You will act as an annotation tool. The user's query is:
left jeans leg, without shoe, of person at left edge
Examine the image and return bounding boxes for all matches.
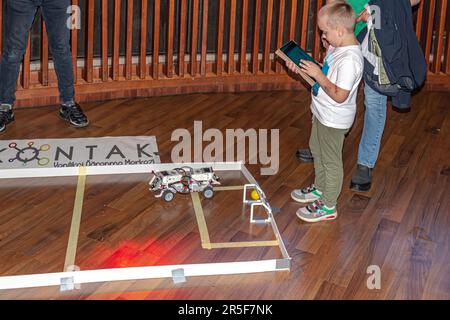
[0,0,37,106]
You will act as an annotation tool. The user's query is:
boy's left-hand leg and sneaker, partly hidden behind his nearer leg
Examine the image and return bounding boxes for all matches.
[291,117,325,203]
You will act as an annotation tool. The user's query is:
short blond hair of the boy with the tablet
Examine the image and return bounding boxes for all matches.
[319,0,356,33]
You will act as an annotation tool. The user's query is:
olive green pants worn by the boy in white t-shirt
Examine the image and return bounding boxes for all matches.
[309,116,349,208]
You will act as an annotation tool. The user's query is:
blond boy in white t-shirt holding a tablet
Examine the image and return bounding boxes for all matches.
[287,1,364,222]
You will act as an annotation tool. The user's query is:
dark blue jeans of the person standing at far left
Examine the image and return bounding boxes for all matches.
[0,0,74,105]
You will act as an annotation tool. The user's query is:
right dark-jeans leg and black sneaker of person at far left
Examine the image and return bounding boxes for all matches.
[42,0,89,127]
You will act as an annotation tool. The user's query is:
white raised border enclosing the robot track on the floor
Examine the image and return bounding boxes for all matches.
[0,162,291,291]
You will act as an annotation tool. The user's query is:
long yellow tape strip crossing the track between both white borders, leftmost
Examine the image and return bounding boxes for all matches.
[64,167,86,271]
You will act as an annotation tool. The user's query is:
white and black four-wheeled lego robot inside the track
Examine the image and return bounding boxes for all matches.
[149,167,220,202]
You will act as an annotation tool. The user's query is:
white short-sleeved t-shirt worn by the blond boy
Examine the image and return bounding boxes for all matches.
[311,45,364,129]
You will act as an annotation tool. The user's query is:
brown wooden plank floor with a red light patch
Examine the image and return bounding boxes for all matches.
[0,91,450,299]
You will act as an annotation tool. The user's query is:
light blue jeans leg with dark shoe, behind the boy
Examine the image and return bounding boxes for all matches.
[350,84,387,191]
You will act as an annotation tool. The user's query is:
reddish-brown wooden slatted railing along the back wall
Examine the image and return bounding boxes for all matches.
[0,0,450,107]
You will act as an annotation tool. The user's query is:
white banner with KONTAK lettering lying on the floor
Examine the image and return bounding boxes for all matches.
[0,136,161,170]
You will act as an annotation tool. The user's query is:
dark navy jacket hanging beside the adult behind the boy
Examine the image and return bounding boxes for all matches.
[358,0,427,109]
